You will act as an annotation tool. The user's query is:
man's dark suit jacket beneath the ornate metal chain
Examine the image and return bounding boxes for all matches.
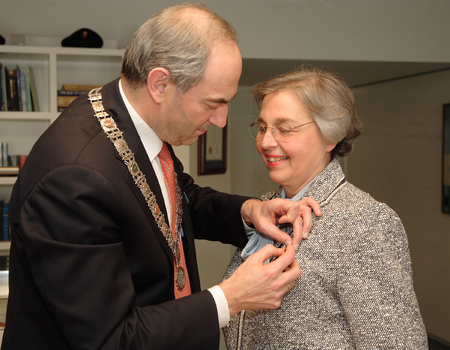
[2,80,247,350]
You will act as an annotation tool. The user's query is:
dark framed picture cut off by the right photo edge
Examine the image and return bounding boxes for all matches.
[442,104,450,213]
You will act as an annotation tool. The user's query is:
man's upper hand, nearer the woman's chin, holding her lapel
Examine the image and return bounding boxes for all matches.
[241,197,322,250]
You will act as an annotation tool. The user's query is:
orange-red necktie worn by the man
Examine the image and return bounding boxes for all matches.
[159,142,191,299]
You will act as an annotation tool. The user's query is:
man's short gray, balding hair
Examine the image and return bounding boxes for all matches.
[121,3,237,93]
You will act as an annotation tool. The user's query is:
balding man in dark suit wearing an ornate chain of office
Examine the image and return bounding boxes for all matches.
[2,4,318,350]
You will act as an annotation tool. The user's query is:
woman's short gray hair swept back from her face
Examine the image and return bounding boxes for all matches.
[251,68,362,159]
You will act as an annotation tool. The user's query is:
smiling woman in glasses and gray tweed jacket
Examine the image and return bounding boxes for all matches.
[224,69,428,350]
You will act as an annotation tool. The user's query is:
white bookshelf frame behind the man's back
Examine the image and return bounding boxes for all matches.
[0,45,124,255]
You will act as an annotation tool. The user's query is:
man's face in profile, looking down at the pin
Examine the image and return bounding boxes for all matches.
[155,42,242,146]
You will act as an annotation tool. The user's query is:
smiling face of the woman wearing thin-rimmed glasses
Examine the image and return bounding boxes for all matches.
[256,90,335,198]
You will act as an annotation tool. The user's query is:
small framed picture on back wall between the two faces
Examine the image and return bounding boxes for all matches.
[197,125,227,175]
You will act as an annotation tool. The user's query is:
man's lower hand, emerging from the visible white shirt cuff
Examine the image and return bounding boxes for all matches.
[219,244,302,317]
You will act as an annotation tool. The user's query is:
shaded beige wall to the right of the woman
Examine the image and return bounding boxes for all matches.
[348,71,450,343]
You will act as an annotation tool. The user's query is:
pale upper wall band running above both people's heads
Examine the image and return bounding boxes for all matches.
[0,0,450,62]
